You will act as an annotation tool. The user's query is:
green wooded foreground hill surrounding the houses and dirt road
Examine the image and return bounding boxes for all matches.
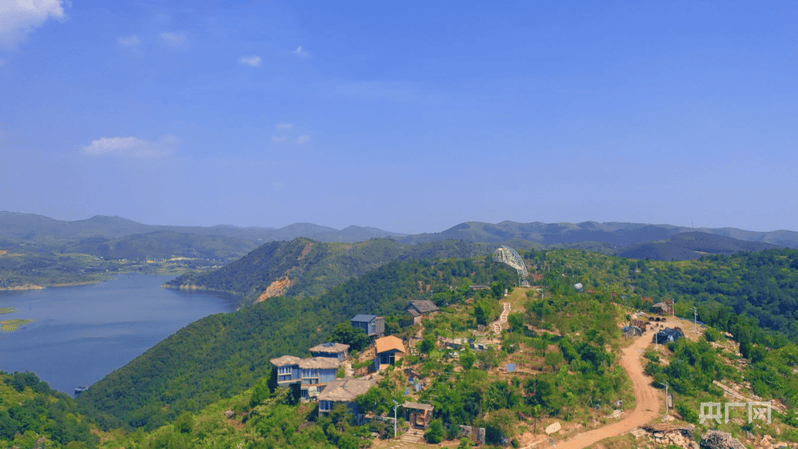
[90,250,798,448]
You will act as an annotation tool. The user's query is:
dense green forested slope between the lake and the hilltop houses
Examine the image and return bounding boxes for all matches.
[79,254,517,429]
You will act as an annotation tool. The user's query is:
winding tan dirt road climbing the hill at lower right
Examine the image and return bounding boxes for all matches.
[556,335,664,449]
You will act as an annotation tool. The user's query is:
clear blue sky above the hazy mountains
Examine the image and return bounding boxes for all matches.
[0,0,798,233]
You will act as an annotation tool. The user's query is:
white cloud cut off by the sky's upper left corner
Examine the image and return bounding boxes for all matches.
[0,0,66,49]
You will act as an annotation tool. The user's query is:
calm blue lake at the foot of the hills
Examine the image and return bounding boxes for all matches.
[0,274,235,394]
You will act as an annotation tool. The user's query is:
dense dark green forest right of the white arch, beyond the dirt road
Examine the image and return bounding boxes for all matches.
[525,249,798,339]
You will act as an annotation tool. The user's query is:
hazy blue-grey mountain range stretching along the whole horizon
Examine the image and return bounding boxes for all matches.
[0,212,798,260]
